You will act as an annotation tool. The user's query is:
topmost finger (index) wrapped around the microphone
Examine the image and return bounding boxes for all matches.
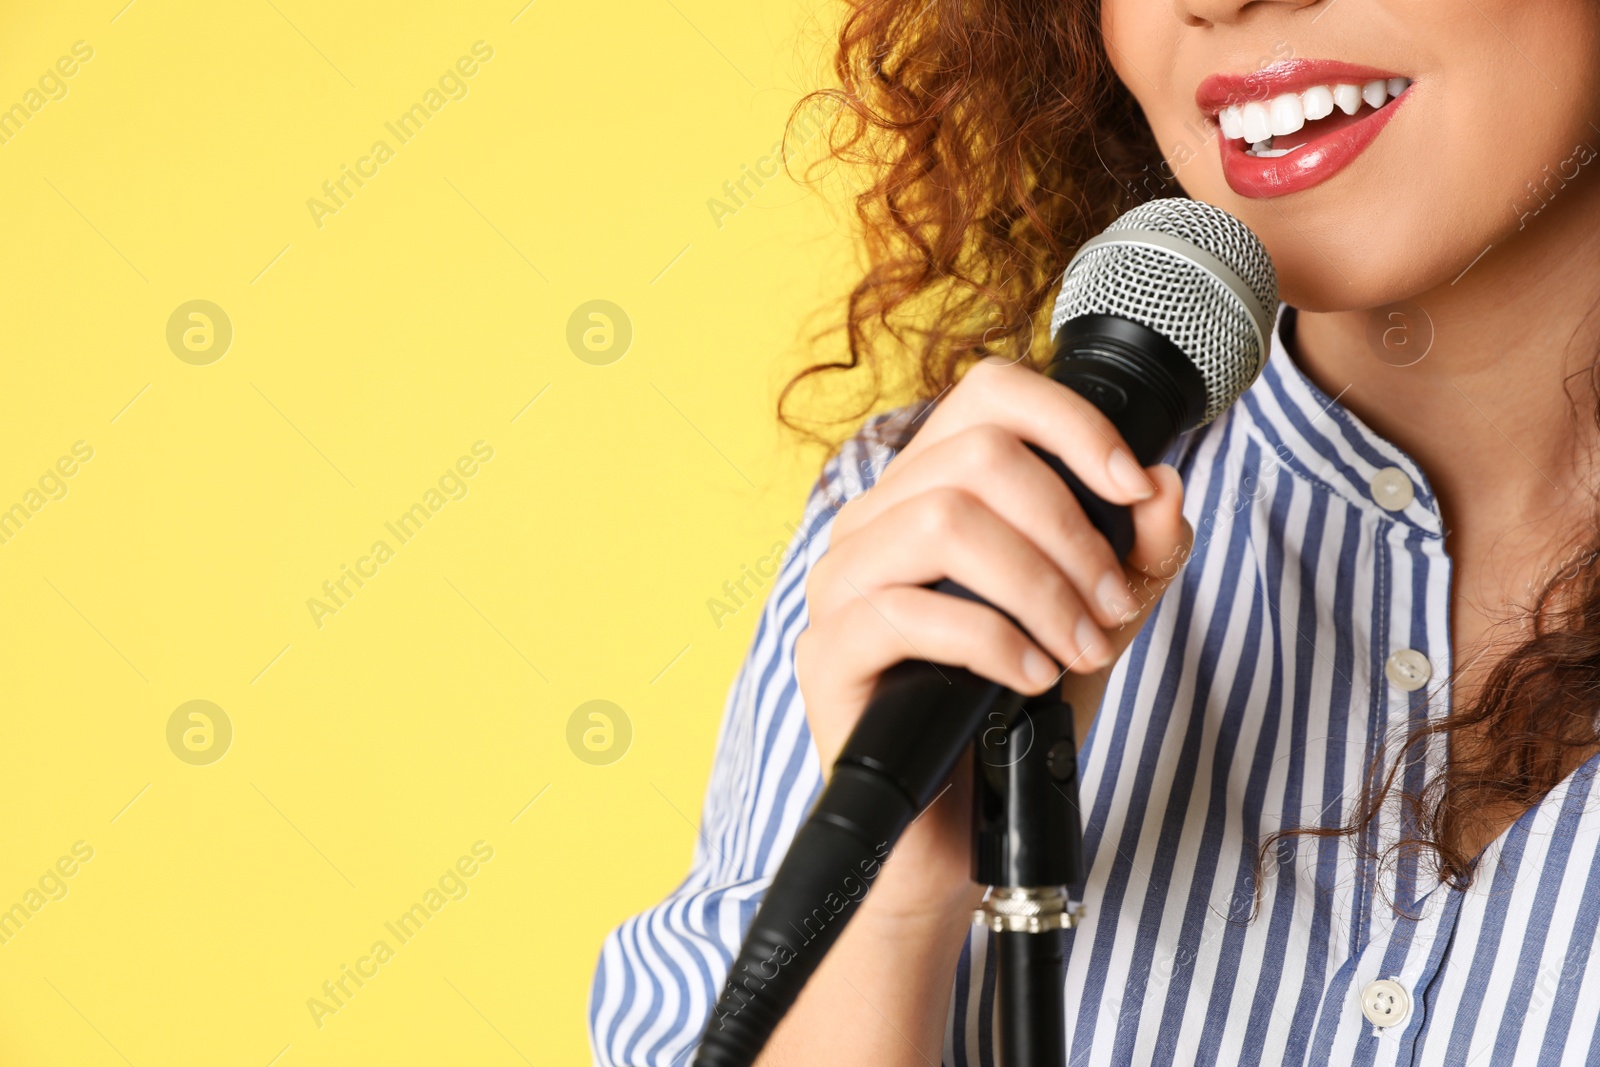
[886,360,1155,504]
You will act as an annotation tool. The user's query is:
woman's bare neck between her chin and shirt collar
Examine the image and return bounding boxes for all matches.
[1291,187,1600,547]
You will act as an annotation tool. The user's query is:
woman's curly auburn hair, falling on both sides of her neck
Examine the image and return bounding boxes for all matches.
[778,0,1600,899]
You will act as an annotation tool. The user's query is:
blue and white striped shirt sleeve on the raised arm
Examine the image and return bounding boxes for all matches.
[589,406,926,1067]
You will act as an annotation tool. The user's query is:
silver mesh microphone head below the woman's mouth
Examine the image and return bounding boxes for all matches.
[1050,198,1278,426]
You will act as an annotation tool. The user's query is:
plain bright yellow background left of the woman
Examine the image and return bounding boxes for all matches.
[0,0,851,1067]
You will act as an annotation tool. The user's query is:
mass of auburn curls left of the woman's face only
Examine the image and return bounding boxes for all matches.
[778,0,1176,443]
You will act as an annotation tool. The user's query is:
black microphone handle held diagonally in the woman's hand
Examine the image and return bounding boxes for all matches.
[694,315,1206,1067]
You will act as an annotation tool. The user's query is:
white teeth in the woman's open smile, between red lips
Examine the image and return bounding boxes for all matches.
[1213,78,1411,160]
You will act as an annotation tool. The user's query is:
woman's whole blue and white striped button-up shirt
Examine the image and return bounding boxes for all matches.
[590,303,1600,1067]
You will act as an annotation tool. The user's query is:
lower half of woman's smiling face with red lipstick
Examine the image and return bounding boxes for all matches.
[1101,0,1600,310]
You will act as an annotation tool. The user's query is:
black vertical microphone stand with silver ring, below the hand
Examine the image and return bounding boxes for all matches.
[973,689,1086,1067]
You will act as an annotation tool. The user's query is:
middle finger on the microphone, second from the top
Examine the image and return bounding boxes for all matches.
[832,426,1141,627]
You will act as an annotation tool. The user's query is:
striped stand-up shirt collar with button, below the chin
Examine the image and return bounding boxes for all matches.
[1238,304,1443,537]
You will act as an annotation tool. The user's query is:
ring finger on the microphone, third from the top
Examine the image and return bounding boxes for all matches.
[806,486,1112,670]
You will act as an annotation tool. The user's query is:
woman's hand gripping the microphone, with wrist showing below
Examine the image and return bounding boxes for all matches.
[795,362,1192,929]
